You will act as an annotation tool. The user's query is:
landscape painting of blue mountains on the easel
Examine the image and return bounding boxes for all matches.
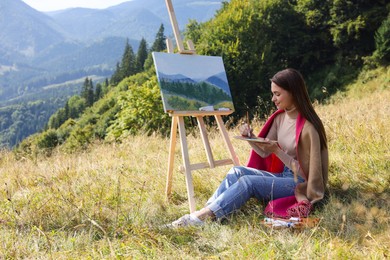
[153,52,234,112]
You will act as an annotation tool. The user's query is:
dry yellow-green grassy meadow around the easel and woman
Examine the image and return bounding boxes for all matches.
[0,68,390,259]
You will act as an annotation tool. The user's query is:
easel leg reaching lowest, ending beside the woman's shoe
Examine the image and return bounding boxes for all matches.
[179,116,195,213]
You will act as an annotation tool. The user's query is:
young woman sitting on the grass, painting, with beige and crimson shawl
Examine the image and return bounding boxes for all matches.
[172,69,328,227]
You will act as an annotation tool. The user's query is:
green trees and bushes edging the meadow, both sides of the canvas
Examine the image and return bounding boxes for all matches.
[12,0,390,153]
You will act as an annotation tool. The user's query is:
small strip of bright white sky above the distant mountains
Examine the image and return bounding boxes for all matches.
[23,0,131,12]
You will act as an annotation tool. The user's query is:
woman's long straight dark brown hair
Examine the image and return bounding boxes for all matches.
[271,68,328,149]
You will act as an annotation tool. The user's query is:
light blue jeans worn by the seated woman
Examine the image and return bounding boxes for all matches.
[206,166,304,218]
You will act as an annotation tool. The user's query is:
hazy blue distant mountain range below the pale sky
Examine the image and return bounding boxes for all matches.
[0,0,222,107]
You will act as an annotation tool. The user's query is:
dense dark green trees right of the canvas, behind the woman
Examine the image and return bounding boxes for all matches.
[185,0,390,115]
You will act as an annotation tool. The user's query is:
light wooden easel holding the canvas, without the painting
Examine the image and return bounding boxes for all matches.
[165,0,240,213]
